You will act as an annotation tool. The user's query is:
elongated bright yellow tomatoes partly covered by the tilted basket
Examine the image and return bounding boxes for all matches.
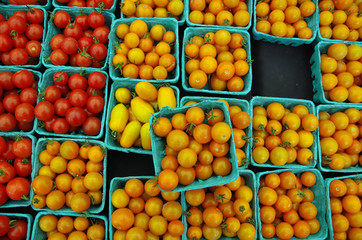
[109,82,177,150]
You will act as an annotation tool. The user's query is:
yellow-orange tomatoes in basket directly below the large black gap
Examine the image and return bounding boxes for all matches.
[252,102,319,166]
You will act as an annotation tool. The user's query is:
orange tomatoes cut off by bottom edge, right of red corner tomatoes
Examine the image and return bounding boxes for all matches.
[38,214,106,240]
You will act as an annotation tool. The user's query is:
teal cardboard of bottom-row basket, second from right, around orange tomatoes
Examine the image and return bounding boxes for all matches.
[255,169,328,240]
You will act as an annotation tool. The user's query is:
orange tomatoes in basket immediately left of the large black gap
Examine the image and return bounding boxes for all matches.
[185,30,249,92]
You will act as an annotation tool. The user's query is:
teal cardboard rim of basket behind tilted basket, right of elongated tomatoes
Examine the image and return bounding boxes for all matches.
[180,96,252,169]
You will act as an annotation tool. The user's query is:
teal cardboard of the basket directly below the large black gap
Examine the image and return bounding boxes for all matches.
[248,97,318,169]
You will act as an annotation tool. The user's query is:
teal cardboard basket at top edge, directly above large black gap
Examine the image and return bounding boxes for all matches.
[253,0,319,47]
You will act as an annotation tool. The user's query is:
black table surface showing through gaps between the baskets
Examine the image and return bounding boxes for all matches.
[0,4,350,232]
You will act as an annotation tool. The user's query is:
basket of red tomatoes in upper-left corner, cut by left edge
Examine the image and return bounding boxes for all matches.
[0,7,47,68]
